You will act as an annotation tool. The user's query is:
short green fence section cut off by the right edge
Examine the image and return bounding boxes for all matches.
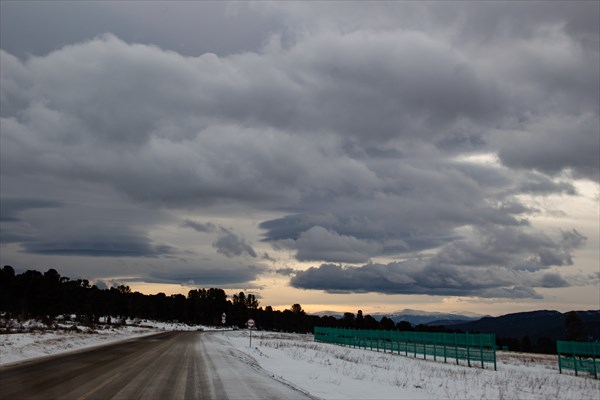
[556,340,600,378]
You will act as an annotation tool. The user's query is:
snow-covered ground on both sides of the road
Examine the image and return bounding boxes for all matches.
[0,321,600,400]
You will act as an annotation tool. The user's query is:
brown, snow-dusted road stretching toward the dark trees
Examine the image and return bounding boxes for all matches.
[0,332,308,400]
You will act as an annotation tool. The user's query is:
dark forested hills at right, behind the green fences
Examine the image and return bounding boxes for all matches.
[440,310,600,340]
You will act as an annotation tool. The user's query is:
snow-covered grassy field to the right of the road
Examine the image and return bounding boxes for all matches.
[222,331,600,400]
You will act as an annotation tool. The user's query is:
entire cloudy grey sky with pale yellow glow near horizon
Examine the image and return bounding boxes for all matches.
[0,1,600,314]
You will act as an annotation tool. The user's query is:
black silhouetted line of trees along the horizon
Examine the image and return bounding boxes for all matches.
[0,265,450,333]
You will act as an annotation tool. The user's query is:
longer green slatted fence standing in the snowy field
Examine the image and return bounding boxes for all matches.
[314,327,496,370]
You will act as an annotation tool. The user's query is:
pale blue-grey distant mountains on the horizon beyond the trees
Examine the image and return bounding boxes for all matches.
[313,309,483,325]
